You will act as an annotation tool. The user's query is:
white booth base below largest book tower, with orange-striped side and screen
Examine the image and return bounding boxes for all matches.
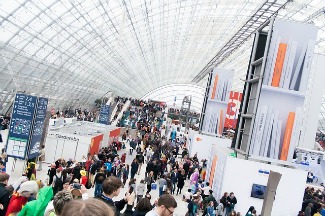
[206,144,307,215]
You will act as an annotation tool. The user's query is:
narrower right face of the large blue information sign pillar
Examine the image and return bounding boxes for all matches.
[28,97,48,159]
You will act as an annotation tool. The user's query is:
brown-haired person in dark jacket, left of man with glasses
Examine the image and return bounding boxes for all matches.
[96,176,127,216]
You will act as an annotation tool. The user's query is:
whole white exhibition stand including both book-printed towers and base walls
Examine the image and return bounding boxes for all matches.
[200,19,325,215]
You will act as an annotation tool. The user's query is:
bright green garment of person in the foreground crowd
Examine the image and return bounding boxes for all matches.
[18,186,53,216]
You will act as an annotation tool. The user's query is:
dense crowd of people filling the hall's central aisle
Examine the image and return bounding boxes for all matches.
[0,98,325,216]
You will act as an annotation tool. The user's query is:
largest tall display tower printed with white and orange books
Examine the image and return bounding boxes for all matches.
[235,20,318,161]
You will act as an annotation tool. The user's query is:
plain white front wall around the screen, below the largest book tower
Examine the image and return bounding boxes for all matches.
[218,157,307,216]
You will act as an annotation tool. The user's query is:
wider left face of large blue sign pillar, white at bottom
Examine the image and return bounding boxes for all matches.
[6,94,37,159]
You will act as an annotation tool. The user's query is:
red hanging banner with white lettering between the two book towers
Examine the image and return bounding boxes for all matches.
[225,91,243,129]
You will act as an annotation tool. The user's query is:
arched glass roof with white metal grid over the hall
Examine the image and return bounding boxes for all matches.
[0,0,325,115]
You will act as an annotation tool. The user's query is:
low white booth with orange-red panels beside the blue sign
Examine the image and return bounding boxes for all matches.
[45,121,120,163]
